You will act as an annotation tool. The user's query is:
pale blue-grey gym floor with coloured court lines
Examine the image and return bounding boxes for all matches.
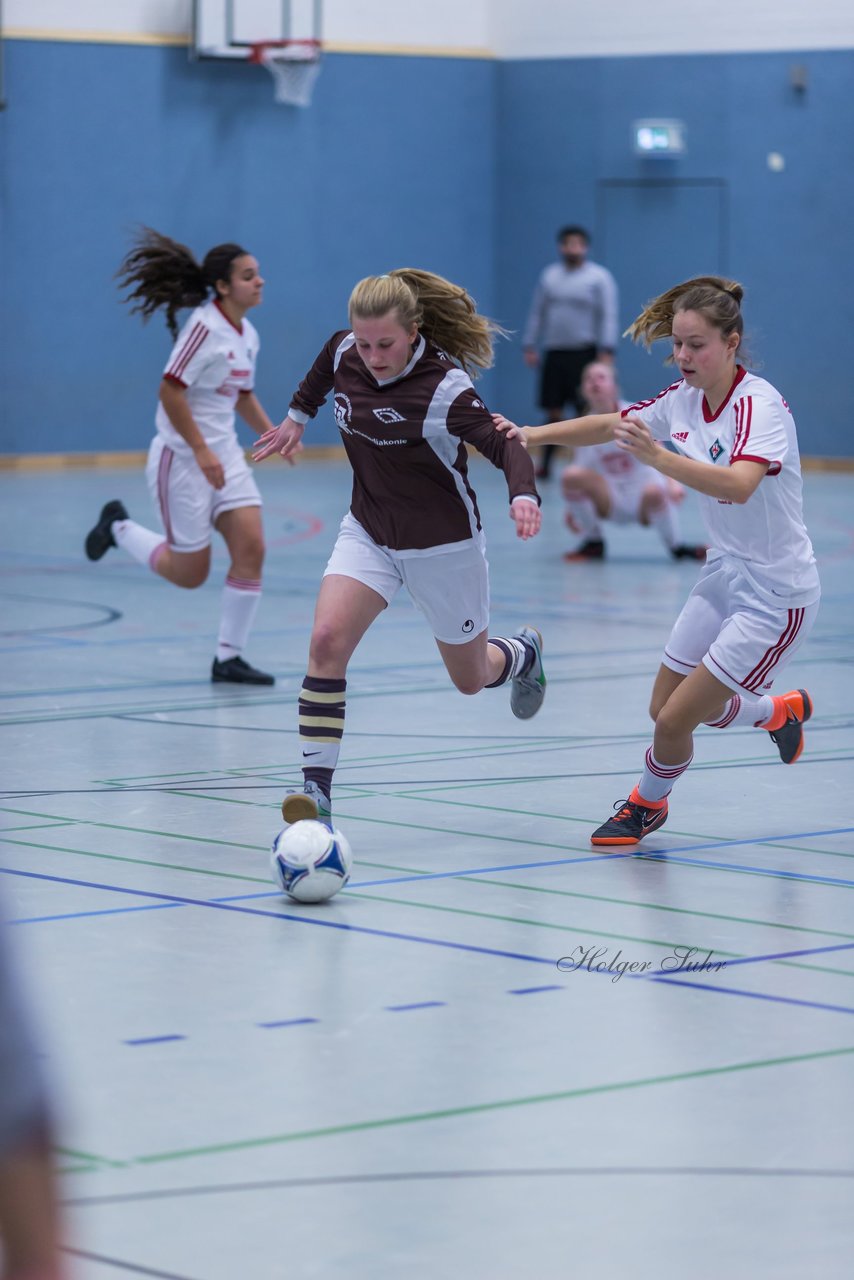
[0,462,854,1280]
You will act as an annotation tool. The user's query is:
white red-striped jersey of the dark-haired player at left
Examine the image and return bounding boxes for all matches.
[155,301,259,453]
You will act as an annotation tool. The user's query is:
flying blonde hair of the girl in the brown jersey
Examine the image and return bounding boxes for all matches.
[348,266,506,378]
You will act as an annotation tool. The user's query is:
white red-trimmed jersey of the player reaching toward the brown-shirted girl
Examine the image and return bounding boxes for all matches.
[622,366,821,608]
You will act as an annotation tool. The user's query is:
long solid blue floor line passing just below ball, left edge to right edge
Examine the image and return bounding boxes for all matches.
[0,867,854,1012]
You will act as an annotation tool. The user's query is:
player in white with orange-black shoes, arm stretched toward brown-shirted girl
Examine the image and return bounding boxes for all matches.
[495,276,821,846]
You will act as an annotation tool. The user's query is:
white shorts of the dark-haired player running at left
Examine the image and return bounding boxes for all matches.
[146,435,262,554]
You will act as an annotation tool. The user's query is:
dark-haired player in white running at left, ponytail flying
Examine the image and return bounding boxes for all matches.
[86,230,274,685]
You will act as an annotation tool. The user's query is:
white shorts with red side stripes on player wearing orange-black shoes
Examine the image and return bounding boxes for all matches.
[662,558,818,698]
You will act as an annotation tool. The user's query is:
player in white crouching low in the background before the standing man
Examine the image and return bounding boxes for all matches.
[561,361,705,562]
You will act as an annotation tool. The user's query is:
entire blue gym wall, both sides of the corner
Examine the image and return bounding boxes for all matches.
[0,40,854,457]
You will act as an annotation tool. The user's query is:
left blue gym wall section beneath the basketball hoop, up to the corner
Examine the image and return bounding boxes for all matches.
[0,41,497,453]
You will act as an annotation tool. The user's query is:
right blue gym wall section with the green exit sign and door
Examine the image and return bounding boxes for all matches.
[494,50,854,457]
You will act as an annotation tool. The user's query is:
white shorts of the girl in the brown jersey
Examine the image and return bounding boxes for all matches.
[324,512,489,644]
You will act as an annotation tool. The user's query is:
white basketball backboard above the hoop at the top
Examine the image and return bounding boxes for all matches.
[191,0,323,59]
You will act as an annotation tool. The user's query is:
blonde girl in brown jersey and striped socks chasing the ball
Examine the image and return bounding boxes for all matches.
[254,269,545,823]
